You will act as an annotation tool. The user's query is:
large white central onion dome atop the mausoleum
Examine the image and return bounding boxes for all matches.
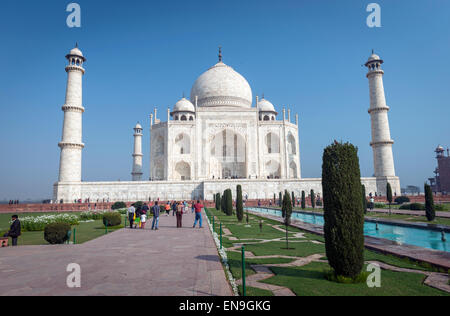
[191,62,252,108]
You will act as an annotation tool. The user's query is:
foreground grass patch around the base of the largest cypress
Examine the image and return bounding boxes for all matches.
[262,262,449,296]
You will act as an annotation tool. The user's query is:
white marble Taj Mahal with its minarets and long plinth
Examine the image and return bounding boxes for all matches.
[53,45,400,203]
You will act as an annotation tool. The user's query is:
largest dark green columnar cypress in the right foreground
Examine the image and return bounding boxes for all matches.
[322,142,364,278]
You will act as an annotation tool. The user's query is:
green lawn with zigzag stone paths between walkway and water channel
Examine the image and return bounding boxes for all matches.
[208,209,449,296]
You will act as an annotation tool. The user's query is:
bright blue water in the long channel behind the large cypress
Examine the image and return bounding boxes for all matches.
[247,207,450,252]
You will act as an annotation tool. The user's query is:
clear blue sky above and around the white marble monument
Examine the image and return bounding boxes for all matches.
[0,0,450,200]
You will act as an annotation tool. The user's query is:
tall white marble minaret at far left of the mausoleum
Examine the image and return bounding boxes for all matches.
[58,45,86,182]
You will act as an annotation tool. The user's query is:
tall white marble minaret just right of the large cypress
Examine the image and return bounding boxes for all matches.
[365,54,395,177]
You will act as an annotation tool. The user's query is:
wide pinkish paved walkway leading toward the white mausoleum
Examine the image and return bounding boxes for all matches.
[0,213,232,296]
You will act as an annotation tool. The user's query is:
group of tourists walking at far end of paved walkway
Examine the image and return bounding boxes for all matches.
[127,200,204,230]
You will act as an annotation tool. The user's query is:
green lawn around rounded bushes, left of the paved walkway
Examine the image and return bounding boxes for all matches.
[0,212,123,246]
